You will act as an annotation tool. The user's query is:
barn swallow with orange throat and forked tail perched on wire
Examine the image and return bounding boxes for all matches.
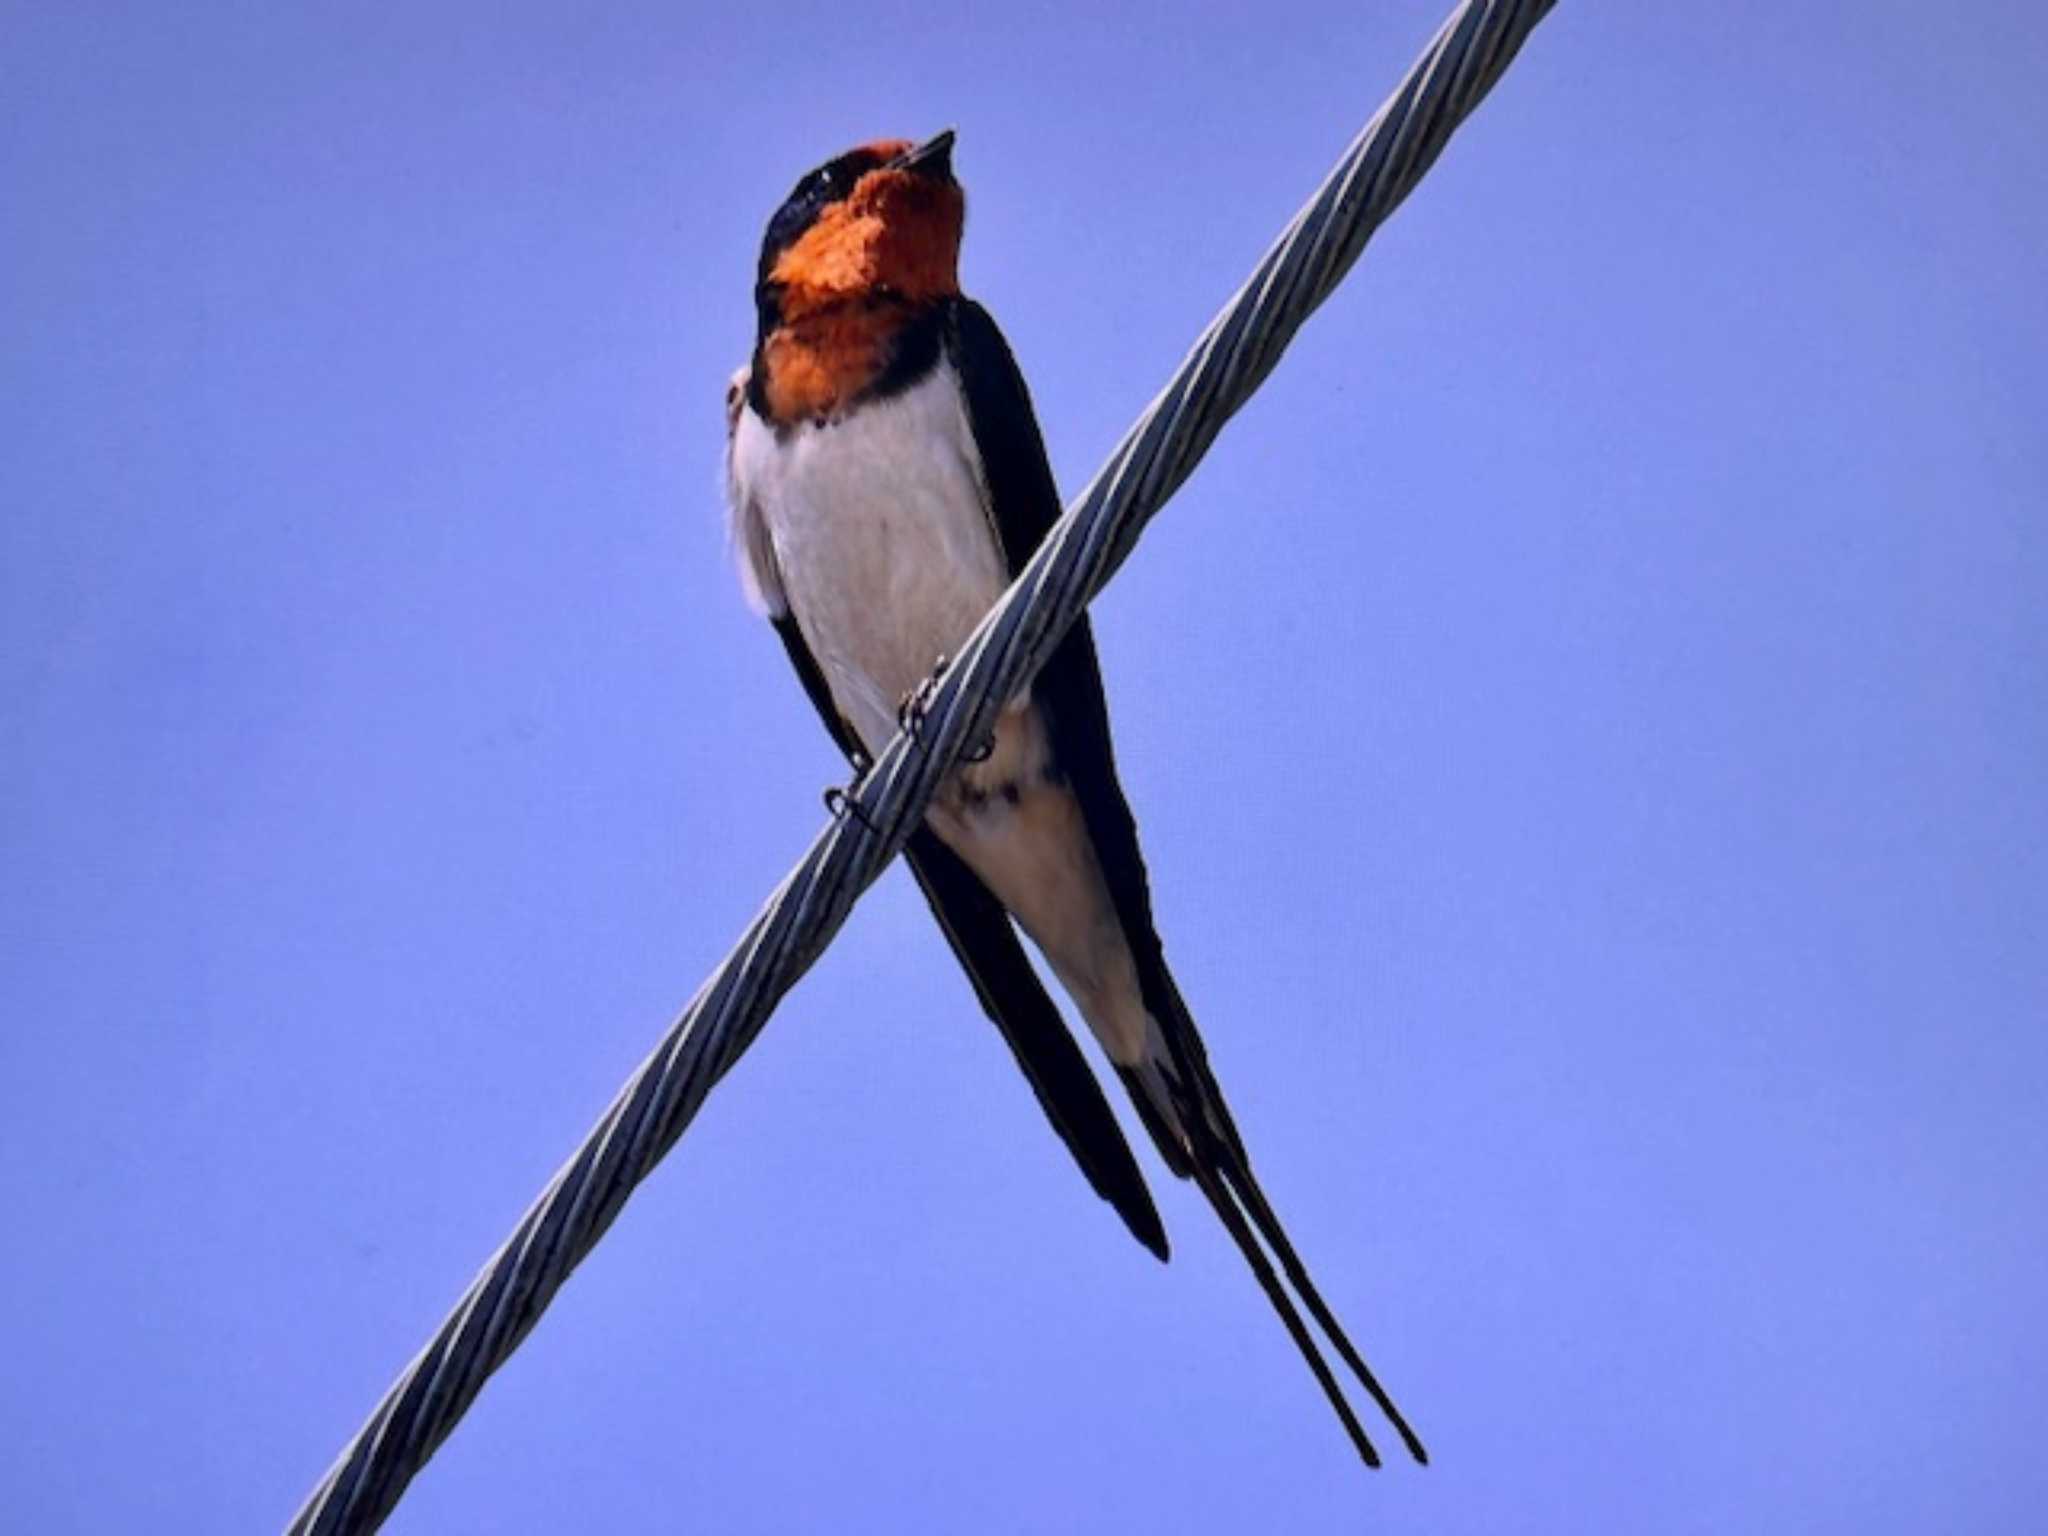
[727,131,1427,1466]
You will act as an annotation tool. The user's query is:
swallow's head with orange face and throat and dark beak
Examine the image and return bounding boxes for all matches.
[754,129,967,334]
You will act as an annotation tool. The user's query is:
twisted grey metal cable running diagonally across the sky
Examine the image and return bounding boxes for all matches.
[287,0,1554,1536]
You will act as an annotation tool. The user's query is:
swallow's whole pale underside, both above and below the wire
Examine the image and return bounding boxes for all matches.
[731,362,1147,1065]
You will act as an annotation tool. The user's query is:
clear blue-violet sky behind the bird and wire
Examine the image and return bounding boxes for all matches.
[0,0,2048,1534]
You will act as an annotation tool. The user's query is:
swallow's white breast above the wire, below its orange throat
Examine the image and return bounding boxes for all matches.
[731,360,1010,750]
